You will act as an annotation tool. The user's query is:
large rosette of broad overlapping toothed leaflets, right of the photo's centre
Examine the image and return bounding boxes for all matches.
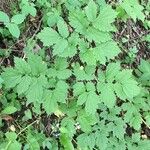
[98,63,140,101]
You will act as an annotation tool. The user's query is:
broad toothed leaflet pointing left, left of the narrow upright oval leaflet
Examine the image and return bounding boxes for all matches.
[37,27,60,46]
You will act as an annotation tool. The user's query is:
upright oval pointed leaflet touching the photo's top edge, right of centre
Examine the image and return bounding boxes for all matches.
[85,0,97,22]
